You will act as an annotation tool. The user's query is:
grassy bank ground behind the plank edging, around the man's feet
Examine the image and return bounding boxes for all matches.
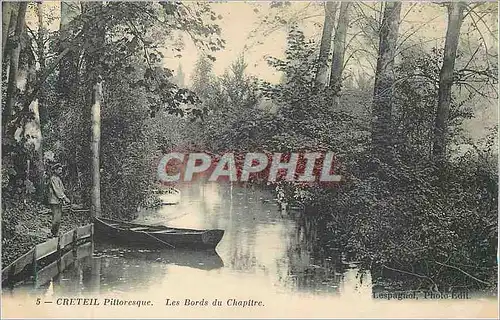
[2,202,91,269]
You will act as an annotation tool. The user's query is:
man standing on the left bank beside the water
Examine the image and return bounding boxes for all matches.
[48,163,70,237]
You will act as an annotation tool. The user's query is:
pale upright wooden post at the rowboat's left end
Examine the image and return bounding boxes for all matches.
[90,77,102,217]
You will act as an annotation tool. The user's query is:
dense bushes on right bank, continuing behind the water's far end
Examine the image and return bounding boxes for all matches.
[182,28,498,290]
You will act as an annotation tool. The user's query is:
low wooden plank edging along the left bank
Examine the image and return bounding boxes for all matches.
[2,223,94,283]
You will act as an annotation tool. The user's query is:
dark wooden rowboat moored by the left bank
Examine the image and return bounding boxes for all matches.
[94,218,224,249]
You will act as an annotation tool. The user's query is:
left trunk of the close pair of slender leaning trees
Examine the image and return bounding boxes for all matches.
[315,1,337,87]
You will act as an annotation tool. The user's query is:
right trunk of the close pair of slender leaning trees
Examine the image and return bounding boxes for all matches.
[330,1,351,104]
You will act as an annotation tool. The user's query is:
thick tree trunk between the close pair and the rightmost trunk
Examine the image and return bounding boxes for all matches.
[372,1,401,160]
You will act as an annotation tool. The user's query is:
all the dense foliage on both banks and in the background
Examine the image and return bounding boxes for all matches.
[2,2,498,290]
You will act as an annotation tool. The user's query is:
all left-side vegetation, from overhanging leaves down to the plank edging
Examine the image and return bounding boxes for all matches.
[2,2,224,262]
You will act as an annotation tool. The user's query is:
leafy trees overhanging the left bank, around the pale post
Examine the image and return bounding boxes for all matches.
[2,2,224,217]
